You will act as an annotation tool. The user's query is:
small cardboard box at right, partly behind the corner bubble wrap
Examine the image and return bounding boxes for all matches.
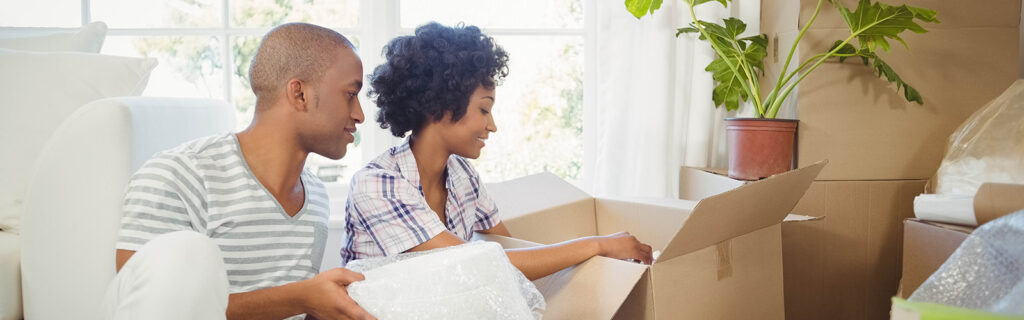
[899,218,974,298]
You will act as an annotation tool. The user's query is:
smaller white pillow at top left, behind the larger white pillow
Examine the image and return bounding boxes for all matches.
[0,22,106,53]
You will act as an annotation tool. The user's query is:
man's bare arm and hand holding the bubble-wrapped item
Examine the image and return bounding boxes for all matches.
[116,249,374,320]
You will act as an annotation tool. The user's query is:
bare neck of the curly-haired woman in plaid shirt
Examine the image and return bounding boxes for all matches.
[409,131,452,189]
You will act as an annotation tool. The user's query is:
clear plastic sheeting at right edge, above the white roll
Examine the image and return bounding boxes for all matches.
[935,79,1024,196]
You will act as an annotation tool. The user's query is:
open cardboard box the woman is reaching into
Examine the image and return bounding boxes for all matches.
[477,162,825,319]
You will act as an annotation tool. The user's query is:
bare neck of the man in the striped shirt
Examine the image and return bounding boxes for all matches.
[237,120,308,198]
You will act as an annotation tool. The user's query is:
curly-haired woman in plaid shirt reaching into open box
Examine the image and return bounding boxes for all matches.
[341,23,651,280]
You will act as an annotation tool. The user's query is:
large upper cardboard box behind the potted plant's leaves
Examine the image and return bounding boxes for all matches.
[761,0,1021,181]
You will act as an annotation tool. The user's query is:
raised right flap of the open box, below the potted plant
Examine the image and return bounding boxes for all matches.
[655,160,827,264]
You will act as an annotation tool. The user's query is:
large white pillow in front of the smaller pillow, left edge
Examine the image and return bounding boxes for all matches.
[0,49,157,233]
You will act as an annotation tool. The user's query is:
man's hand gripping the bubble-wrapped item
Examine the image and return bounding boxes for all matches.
[303,268,376,320]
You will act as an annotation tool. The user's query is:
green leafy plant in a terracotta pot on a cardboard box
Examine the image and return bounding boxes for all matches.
[626,0,939,179]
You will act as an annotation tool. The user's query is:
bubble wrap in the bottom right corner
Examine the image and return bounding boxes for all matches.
[908,210,1024,315]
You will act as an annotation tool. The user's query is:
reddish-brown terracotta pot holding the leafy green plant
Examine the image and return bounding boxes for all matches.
[725,118,800,181]
